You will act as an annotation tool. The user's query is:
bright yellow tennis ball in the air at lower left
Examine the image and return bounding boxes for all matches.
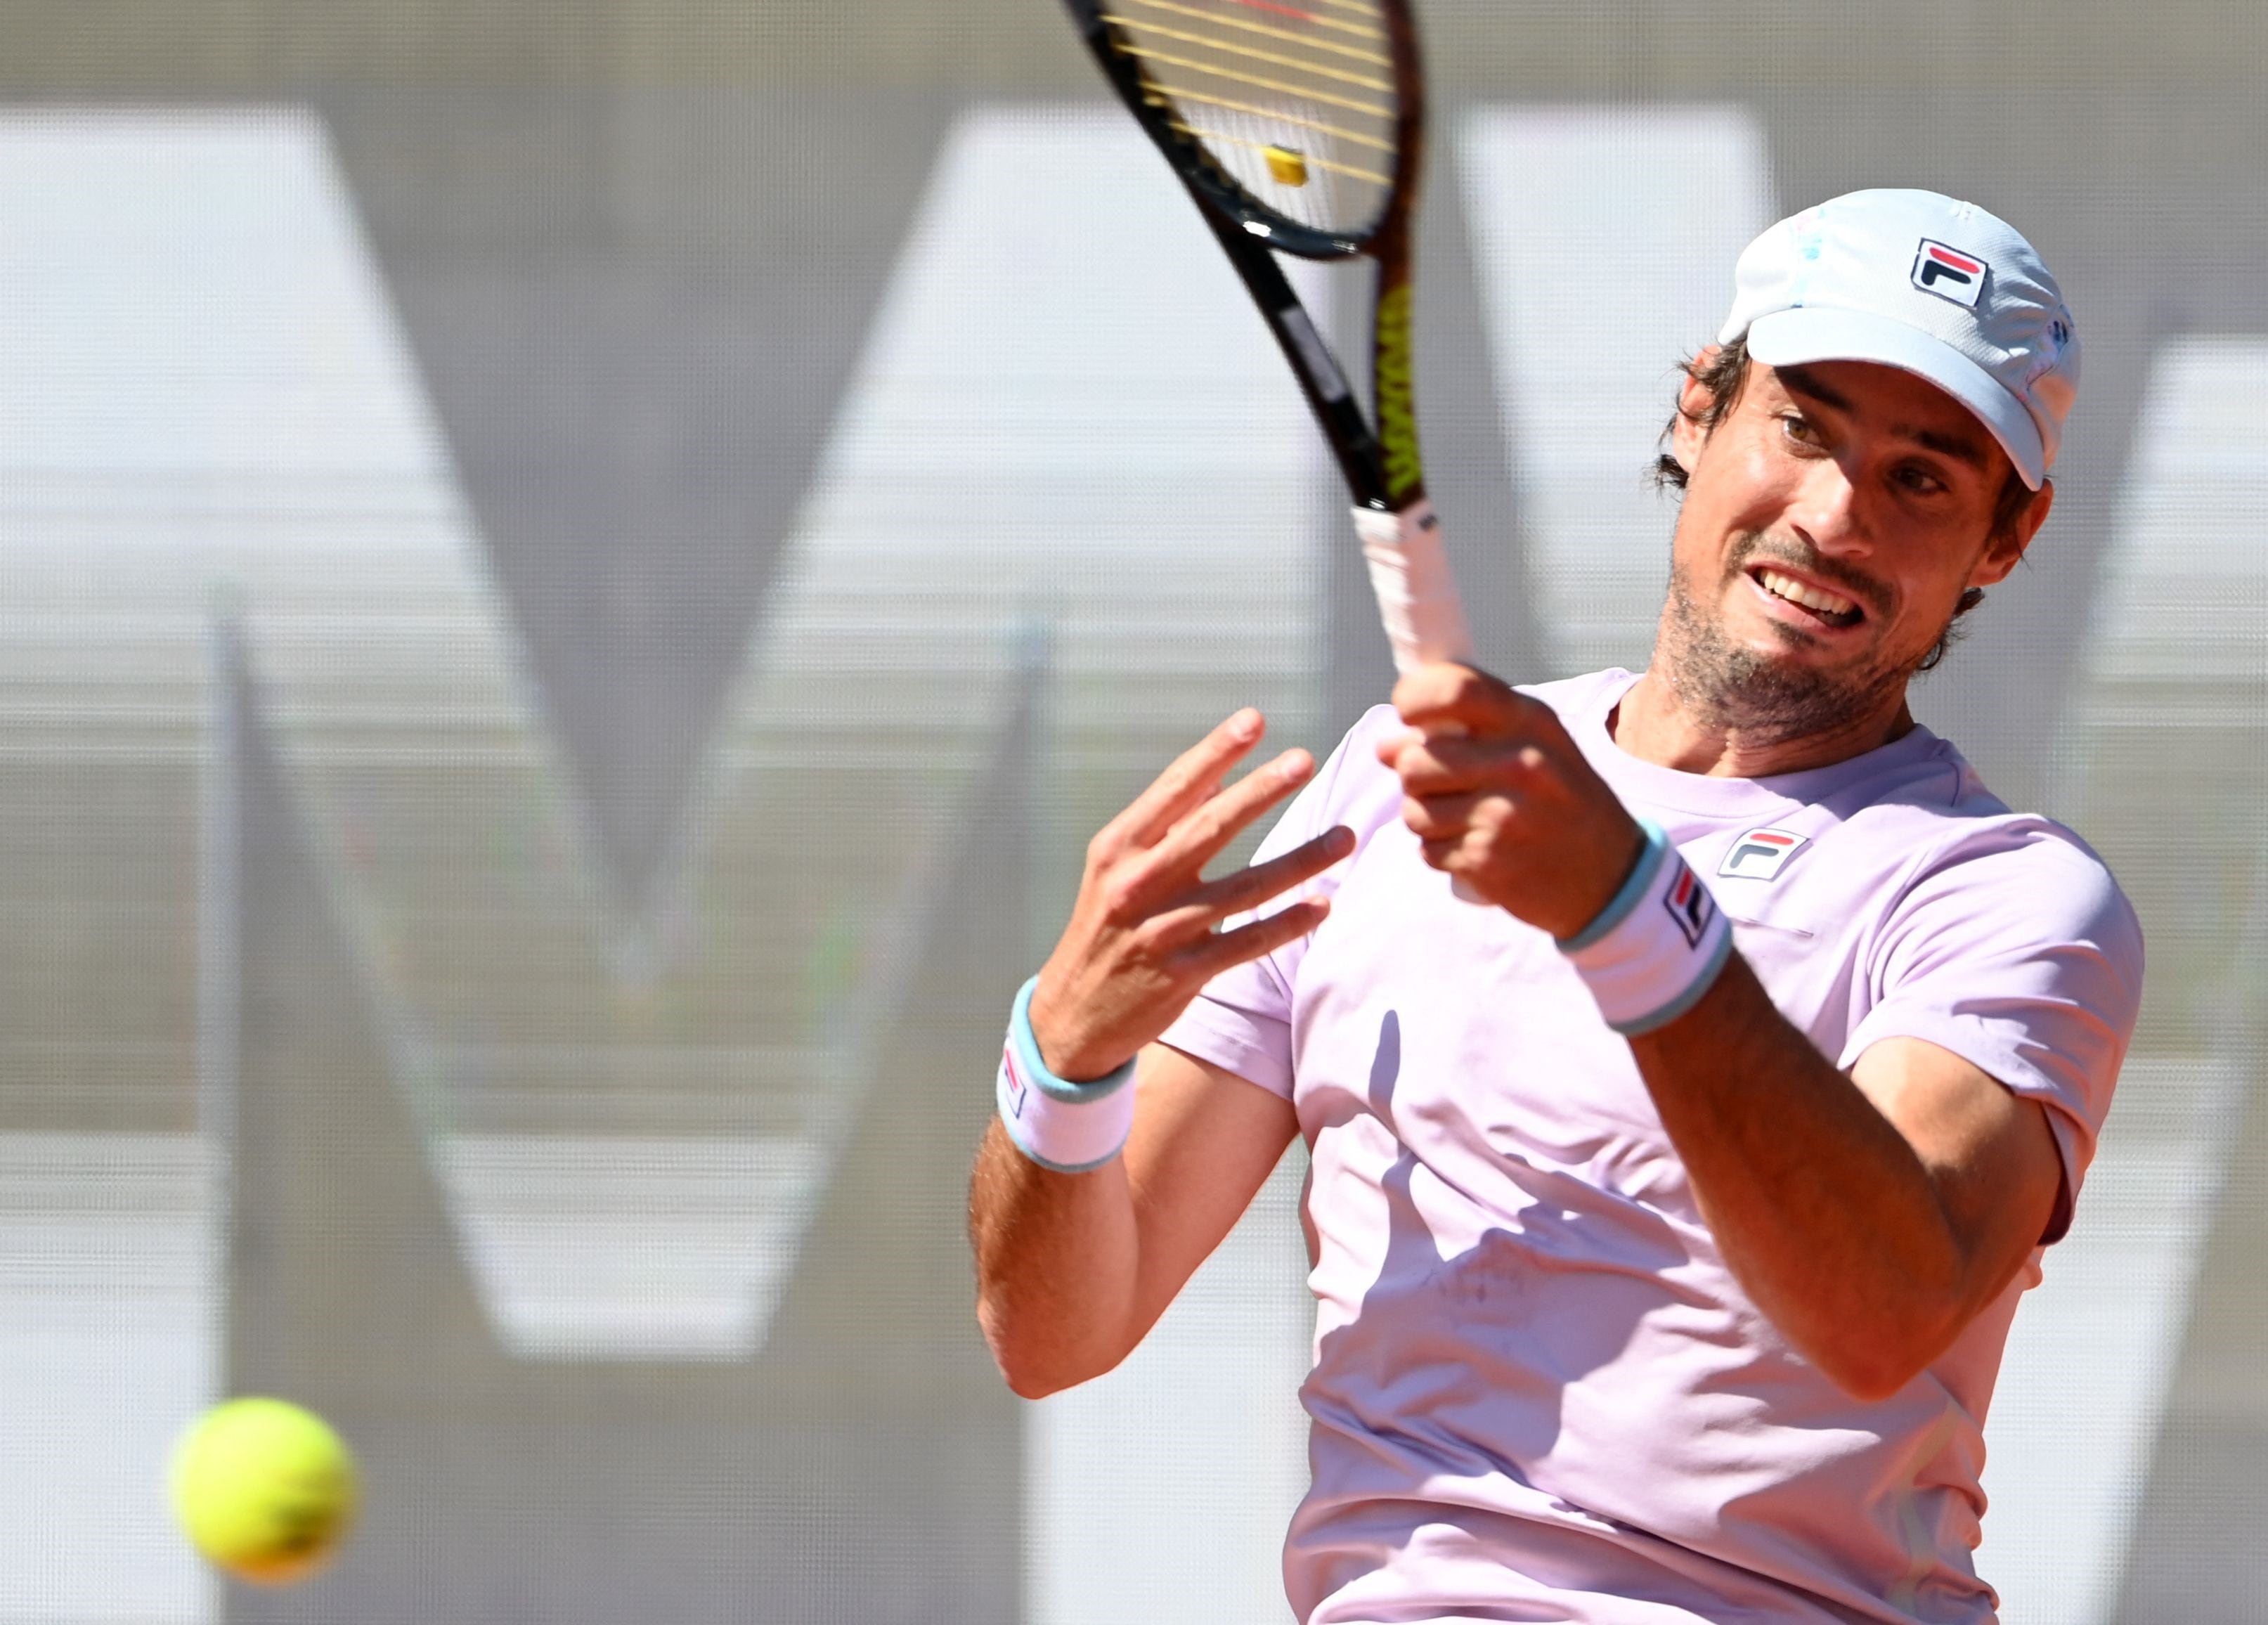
[172,1398,354,1586]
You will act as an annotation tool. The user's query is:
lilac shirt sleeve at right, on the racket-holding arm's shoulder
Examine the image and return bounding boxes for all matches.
[1839,820,2144,1241]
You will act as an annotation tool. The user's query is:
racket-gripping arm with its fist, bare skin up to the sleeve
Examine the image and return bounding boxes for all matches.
[1379,667,2113,1398]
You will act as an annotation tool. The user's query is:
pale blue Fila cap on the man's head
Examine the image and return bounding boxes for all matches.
[1717,190,2080,490]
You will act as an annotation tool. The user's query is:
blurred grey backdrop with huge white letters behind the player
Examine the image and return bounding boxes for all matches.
[0,0,2268,1625]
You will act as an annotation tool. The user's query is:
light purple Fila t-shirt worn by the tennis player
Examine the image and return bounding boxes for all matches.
[1166,672,2141,1625]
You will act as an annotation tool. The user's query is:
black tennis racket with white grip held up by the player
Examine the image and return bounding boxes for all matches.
[1063,0,1472,672]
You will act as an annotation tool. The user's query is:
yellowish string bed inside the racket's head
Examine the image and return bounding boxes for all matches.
[1105,0,1397,236]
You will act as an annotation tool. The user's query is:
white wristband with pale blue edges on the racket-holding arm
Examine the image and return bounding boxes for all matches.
[1558,820,1732,1037]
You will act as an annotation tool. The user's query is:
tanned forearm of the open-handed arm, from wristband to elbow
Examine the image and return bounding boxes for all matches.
[968,1121,1141,1398]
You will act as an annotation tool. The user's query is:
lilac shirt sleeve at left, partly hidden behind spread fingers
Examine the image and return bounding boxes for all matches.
[1159,706,1401,1101]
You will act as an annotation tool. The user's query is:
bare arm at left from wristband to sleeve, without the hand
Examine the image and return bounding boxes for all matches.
[968,1044,1297,1400]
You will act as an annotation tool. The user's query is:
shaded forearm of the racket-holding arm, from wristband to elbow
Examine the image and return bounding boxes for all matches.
[1631,953,1998,1396]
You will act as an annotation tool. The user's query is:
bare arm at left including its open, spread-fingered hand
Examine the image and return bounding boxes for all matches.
[968,711,1354,1398]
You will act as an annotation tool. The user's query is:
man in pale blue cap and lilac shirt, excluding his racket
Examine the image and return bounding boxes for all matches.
[971,190,2144,1625]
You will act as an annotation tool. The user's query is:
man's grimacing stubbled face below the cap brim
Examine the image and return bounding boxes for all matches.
[1662,361,2050,740]
